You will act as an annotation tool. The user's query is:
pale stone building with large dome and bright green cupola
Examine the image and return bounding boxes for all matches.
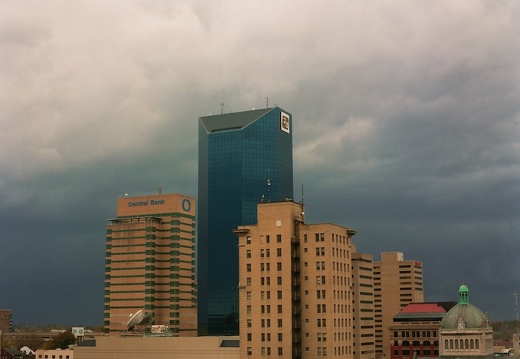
[440,284,493,357]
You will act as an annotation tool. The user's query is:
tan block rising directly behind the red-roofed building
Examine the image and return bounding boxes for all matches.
[374,252,424,358]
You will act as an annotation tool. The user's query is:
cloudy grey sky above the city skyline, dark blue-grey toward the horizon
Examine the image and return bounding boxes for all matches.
[0,0,520,325]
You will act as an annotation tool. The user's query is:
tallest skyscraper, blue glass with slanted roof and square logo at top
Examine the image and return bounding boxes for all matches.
[197,107,293,335]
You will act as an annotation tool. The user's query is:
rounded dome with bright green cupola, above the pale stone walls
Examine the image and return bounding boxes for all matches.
[441,284,488,329]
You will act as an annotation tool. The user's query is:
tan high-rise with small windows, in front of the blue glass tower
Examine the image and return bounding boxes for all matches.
[234,201,355,358]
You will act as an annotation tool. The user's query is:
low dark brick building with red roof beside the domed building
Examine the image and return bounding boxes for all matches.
[388,302,456,359]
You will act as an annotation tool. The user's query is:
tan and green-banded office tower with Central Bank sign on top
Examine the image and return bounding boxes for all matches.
[104,194,197,336]
